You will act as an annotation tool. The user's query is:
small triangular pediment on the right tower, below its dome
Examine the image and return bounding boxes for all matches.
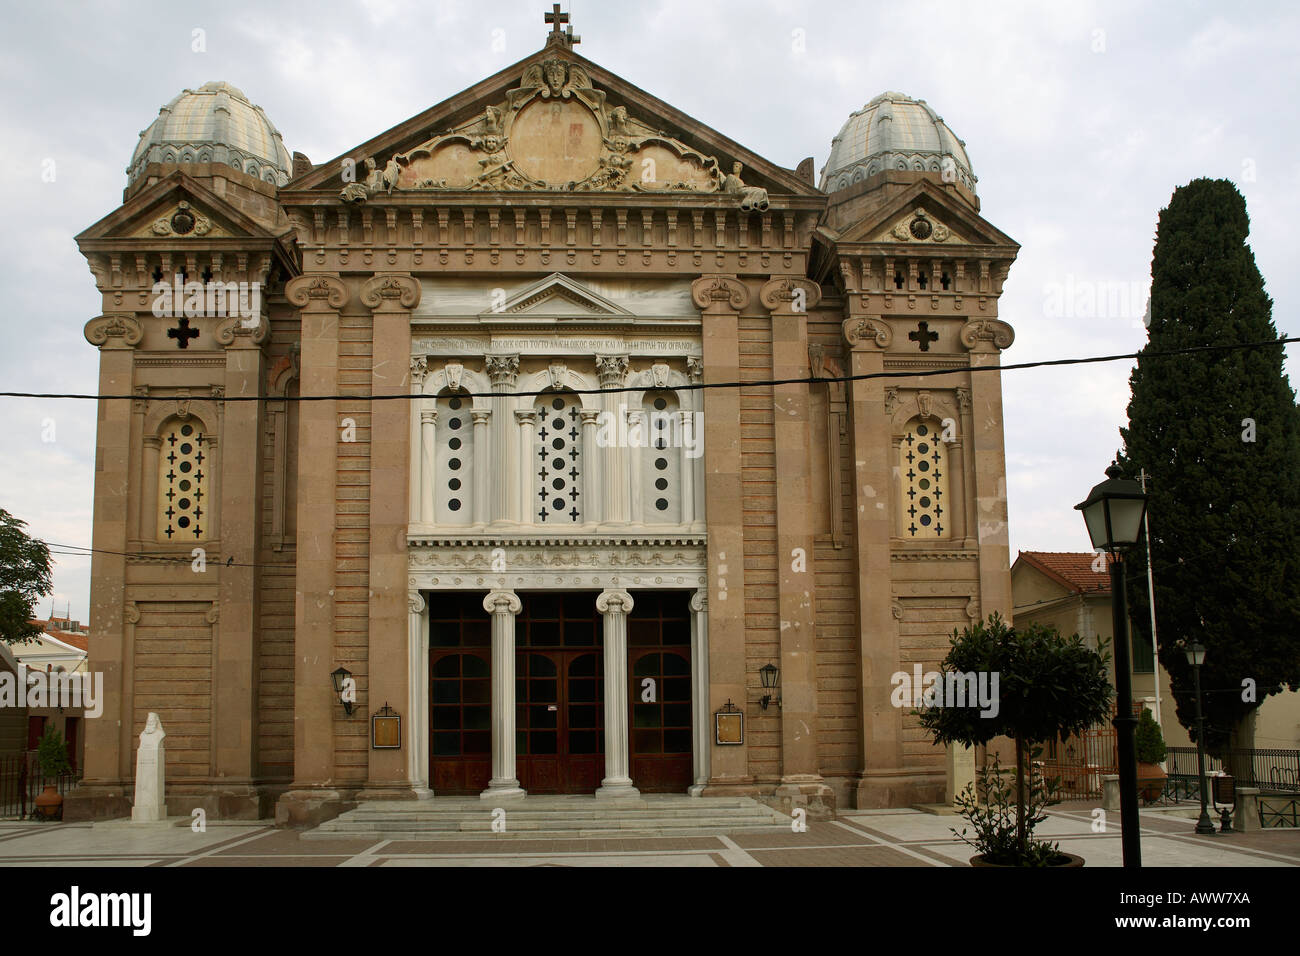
[836,179,1019,248]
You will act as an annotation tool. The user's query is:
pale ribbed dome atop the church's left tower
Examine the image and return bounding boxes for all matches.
[126,82,294,186]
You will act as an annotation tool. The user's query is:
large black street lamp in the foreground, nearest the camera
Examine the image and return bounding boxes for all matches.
[1074,464,1147,868]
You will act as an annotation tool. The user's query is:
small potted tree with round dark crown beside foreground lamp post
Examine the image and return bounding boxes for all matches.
[918,611,1112,866]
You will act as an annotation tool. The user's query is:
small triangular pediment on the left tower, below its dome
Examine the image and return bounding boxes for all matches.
[77,170,277,243]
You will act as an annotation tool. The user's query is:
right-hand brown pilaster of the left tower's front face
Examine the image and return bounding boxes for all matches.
[208,316,270,818]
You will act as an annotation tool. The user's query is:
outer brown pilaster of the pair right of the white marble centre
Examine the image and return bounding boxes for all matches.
[759,277,835,817]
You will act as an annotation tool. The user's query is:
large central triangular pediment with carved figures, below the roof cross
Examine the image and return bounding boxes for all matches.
[282,46,822,201]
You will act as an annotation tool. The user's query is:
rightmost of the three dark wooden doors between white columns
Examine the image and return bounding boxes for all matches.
[628,591,694,793]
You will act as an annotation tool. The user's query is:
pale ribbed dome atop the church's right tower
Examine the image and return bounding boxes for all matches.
[822,92,975,193]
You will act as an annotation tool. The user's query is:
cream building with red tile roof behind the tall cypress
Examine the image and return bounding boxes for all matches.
[1011,551,1300,749]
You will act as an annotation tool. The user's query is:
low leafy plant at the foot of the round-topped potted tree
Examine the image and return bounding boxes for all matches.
[952,754,1063,866]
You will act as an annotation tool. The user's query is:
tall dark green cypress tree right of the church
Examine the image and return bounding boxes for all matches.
[1119,179,1300,752]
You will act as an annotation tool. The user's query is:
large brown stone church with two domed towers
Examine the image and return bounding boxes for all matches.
[68,14,1018,825]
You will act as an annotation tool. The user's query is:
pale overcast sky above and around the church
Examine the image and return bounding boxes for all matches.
[0,0,1300,620]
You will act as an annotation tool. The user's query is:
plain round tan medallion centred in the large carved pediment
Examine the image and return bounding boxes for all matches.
[508,99,601,185]
